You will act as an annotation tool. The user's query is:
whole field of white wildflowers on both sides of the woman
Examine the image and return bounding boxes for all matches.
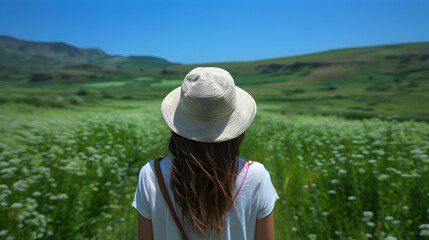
[0,102,429,240]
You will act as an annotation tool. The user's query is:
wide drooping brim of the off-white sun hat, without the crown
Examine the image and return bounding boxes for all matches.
[161,87,256,142]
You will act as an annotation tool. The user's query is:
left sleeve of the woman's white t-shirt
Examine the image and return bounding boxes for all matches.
[131,163,152,219]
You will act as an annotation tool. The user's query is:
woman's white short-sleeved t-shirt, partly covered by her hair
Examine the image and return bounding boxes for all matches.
[132,157,279,240]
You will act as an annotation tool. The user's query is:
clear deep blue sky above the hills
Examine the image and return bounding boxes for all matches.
[0,0,429,64]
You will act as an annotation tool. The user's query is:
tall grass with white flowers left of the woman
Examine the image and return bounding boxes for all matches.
[0,109,170,239]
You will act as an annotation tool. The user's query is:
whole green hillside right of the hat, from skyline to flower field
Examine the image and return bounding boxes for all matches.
[144,42,429,119]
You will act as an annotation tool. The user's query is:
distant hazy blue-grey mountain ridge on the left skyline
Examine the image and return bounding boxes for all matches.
[0,36,175,70]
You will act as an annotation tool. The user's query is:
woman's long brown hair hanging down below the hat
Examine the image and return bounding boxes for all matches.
[169,132,244,236]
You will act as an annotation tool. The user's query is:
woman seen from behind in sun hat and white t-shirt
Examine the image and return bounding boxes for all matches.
[132,68,278,240]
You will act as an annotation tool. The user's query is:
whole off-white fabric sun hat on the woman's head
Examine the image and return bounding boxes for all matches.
[161,67,256,142]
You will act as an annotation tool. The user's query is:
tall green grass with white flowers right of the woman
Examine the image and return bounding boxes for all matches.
[244,113,429,239]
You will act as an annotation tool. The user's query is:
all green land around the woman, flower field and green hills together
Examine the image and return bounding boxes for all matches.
[0,43,429,240]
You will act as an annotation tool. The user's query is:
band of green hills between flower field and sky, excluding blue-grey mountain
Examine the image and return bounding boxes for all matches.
[0,42,429,121]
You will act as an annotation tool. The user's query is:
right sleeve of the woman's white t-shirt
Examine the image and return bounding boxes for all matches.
[256,167,279,219]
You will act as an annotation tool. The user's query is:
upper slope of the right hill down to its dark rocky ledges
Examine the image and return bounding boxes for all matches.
[149,42,429,85]
